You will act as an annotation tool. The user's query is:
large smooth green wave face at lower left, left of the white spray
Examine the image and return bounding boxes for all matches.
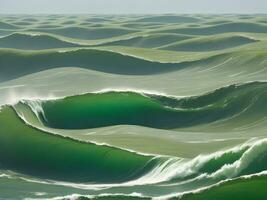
[0,106,157,183]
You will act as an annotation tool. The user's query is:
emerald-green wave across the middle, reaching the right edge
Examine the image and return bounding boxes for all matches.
[22,82,267,129]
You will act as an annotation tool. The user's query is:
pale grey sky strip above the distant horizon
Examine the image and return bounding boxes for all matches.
[0,0,267,14]
